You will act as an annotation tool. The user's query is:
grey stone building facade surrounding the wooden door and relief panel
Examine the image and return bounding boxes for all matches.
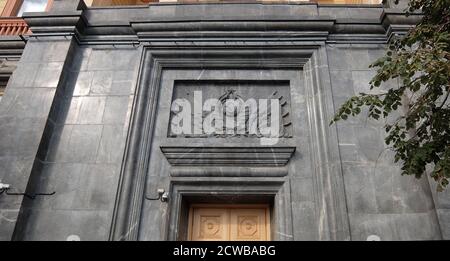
[0,0,450,240]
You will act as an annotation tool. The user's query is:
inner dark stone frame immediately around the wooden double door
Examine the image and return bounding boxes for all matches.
[165,177,294,241]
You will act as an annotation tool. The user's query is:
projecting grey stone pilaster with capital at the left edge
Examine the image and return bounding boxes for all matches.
[0,0,82,241]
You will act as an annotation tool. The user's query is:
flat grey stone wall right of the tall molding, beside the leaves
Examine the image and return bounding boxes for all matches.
[327,44,440,240]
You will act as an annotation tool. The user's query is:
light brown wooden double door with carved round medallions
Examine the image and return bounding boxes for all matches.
[188,204,270,241]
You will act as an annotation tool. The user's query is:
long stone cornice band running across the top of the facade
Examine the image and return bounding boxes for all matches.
[7,4,421,44]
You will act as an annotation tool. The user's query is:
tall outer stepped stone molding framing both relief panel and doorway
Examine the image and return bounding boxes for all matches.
[110,43,350,240]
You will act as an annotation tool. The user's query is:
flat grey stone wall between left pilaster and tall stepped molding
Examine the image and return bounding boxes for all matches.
[5,43,139,240]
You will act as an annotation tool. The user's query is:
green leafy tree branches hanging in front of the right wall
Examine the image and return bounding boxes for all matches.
[332,0,450,191]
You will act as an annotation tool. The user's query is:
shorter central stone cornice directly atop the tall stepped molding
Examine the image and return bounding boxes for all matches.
[131,17,334,41]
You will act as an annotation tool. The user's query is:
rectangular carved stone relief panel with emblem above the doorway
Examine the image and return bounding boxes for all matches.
[168,80,293,138]
